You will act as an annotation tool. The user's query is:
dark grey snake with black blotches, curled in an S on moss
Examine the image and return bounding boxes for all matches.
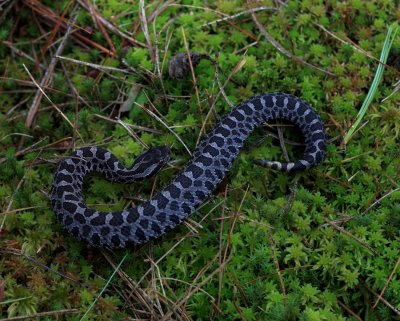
[50,93,328,249]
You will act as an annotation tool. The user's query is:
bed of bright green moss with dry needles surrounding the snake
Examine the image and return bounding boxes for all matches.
[0,0,400,321]
